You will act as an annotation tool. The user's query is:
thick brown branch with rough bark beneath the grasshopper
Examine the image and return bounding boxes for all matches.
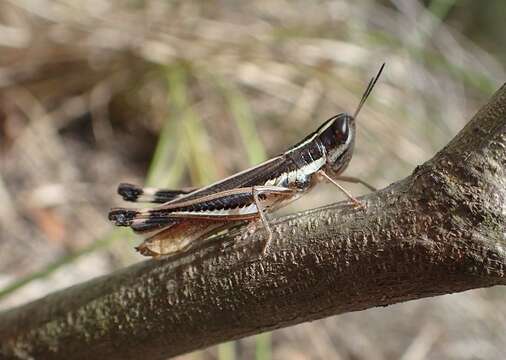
[0,86,506,359]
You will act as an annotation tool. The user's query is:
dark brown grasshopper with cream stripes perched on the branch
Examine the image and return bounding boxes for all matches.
[109,64,385,257]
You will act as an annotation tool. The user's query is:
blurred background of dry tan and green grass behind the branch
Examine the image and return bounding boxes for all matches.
[0,0,506,360]
